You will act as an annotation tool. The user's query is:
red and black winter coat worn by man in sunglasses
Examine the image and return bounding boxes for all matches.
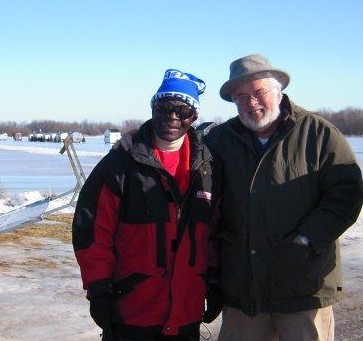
[73,121,216,335]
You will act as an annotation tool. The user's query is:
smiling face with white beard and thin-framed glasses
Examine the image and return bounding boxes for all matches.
[232,78,282,137]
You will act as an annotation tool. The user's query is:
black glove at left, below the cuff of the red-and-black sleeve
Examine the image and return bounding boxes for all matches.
[89,279,115,330]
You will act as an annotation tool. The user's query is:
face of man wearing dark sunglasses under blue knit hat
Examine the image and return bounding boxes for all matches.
[152,101,196,142]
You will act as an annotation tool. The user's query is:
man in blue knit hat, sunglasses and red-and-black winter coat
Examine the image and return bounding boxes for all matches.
[73,70,222,341]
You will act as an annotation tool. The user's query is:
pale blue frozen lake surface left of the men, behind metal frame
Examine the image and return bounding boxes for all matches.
[0,136,111,195]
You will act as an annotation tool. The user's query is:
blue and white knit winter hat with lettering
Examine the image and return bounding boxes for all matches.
[151,69,205,114]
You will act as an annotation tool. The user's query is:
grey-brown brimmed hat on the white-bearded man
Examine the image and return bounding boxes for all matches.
[219,54,290,102]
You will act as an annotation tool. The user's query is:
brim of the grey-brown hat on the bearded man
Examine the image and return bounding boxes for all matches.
[219,70,290,102]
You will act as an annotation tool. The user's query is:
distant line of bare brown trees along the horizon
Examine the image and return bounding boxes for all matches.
[0,107,363,136]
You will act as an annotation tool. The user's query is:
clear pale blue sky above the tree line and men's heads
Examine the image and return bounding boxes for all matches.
[0,0,363,123]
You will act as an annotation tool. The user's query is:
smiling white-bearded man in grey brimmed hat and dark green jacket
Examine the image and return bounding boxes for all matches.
[206,55,363,341]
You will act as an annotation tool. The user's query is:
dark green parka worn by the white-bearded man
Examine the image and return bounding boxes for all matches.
[206,95,363,316]
